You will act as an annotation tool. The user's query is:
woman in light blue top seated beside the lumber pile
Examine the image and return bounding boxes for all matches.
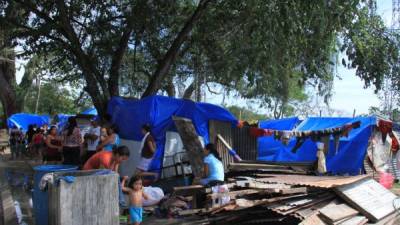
[200,144,225,185]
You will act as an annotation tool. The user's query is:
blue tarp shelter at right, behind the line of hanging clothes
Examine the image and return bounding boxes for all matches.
[259,117,376,174]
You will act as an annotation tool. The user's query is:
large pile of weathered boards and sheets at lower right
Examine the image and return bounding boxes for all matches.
[176,163,400,225]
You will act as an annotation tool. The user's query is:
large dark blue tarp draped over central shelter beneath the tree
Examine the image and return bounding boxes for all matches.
[107,96,237,171]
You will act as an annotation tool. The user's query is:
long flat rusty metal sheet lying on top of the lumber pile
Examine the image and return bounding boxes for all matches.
[257,174,369,188]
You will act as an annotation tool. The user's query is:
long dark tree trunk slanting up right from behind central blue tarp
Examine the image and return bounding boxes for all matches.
[142,0,211,98]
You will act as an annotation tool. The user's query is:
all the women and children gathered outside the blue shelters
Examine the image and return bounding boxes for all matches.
[11,117,224,224]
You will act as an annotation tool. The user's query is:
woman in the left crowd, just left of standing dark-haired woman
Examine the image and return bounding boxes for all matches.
[43,126,62,164]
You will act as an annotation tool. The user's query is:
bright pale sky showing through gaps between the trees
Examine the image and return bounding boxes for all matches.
[17,0,392,116]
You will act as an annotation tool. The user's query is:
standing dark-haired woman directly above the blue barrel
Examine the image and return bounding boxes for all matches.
[62,117,83,165]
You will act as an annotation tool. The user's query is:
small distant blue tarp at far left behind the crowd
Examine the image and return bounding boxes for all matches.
[7,113,50,132]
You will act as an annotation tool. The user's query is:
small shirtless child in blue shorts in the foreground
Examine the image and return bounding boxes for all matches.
[121,176,149,225]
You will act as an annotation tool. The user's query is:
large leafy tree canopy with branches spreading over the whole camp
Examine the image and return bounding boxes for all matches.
[0,0,400,122]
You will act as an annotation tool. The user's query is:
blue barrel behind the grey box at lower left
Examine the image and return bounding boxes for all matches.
[32,165,78,225]
